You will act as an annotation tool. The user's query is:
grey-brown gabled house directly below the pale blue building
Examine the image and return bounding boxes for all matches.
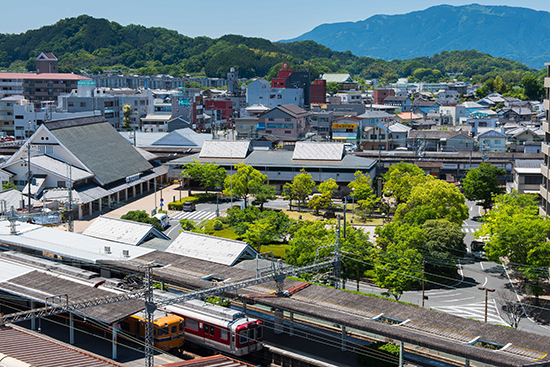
[257,104,310,141]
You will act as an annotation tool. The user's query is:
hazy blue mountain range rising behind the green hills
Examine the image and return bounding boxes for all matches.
[281,4,550,69]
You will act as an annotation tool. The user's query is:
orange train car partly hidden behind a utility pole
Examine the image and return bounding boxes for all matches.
[120,311,185,350]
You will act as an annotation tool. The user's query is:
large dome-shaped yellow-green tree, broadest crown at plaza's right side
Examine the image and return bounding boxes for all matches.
[395,179,468,225]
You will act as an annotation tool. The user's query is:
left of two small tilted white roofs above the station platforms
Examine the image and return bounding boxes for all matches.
[82,215,169,246]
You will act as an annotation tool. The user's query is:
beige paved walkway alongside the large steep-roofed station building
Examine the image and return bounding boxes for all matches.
[74,184,188,233]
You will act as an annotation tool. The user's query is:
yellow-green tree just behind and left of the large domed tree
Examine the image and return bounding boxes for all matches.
[384,162,433,203]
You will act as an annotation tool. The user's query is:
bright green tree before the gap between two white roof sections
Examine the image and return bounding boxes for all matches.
[223,163,267,208]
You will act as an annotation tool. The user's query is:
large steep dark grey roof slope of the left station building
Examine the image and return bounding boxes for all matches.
[44,116,153,185]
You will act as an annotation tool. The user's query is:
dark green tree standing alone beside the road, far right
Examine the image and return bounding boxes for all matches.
[462,162,506,209]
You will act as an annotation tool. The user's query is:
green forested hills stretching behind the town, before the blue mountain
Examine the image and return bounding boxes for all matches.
[0,15,535,83]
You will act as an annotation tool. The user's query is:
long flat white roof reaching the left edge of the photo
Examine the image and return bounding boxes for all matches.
[0,220,154,263]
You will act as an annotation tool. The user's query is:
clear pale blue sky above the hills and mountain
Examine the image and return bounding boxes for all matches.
[0,0,550,41]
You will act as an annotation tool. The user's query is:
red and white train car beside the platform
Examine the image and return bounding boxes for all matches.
[166,300,263,356]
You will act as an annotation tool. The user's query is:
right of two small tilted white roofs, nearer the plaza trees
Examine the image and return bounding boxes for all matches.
[166,231,256,266]
